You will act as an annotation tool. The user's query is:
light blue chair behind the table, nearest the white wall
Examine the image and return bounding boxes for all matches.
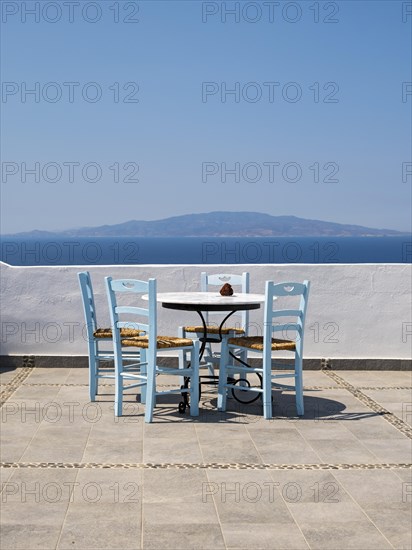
[179,272,249,377]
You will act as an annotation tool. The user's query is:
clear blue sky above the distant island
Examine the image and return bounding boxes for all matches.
[1,0,412,233]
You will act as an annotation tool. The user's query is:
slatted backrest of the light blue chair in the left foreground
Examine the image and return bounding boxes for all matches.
[105,277,157,349]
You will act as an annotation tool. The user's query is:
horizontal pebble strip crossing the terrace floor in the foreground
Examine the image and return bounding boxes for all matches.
[0,462,412,470]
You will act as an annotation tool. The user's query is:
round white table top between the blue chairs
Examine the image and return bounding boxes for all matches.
[157,292,265,306]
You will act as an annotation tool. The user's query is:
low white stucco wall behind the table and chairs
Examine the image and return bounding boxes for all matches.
[0,263,412,359]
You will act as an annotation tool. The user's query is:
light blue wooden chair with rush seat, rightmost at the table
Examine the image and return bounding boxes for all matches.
[218,281,310,418]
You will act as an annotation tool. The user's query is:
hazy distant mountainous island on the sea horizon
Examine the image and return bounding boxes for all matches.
[2,212,410,238]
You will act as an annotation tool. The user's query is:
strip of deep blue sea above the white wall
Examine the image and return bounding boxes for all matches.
[0,235,412,266]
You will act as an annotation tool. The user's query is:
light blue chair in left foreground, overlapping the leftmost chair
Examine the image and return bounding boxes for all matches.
[105,277,199,422]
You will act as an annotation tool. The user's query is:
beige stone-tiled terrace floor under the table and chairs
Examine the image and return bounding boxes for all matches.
[0,366,412,550]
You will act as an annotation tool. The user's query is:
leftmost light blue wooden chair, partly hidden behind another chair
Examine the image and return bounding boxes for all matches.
[77,271,140,401]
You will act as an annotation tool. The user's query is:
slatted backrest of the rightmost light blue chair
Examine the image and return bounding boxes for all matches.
[264,281,310,353]
